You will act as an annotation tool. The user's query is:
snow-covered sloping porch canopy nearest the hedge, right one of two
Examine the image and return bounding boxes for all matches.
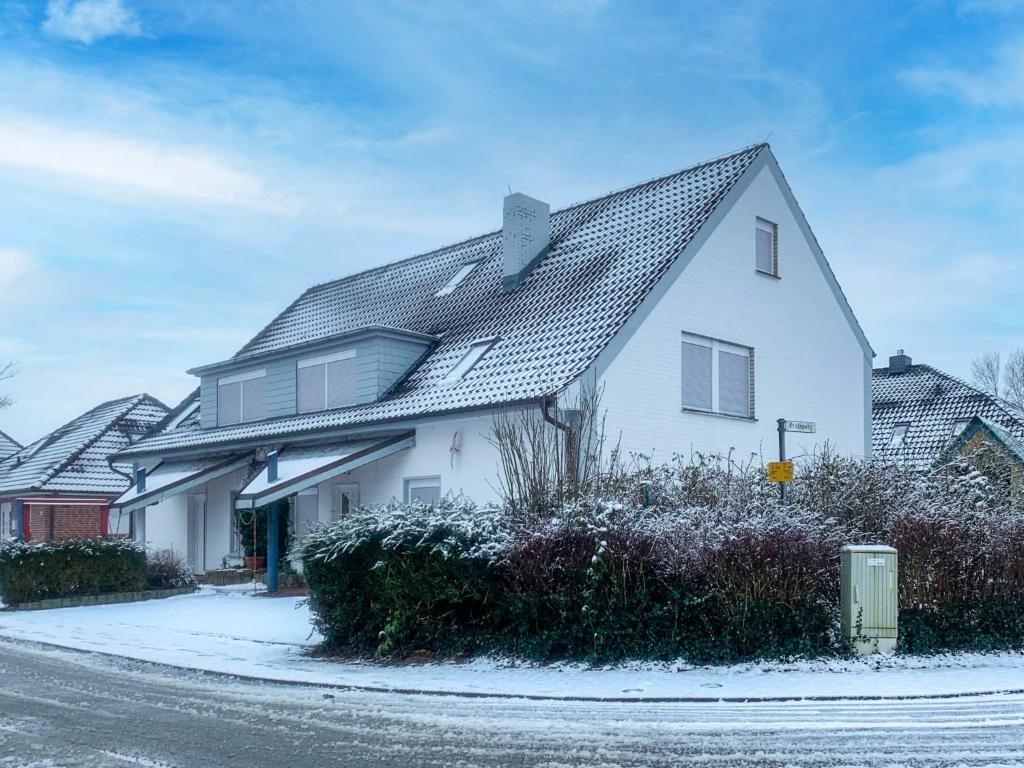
[234,432,416,509]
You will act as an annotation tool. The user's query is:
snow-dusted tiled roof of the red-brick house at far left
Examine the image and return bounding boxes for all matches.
[0,394,168,496]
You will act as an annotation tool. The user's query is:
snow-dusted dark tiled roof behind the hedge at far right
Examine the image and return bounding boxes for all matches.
[871,364,1024,468]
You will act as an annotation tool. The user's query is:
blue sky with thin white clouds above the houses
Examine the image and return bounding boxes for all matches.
[0,0,1024,441]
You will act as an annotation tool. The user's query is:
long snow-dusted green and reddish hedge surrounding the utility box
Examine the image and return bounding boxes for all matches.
[300,453,1024,662]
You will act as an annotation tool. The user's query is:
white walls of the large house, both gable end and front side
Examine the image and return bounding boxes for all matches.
[128,156,871,571]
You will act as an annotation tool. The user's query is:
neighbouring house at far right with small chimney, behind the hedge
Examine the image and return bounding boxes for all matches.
[871,349,1024,469]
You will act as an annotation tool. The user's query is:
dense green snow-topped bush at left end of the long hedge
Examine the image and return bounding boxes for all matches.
[298,499,510,653]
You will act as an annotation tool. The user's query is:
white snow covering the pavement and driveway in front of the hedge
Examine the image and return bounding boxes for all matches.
[0,587,1024,698]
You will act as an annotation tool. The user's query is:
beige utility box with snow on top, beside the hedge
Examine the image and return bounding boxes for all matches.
[840,545,899,653]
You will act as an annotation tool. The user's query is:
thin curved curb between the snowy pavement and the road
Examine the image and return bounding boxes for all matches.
[0,634,1024,705]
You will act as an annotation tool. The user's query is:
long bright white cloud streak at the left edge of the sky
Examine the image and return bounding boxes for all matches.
[0,116,295,213]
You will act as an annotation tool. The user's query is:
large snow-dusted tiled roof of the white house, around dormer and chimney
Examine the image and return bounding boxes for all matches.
[119,144,866,456]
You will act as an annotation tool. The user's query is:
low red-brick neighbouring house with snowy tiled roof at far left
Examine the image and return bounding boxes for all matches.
[0,394,168,541]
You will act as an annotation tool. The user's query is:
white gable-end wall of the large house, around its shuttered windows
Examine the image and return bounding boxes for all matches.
[600,168,870,462]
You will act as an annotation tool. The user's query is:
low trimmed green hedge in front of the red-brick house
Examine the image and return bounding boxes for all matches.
[0,539,146,605]
